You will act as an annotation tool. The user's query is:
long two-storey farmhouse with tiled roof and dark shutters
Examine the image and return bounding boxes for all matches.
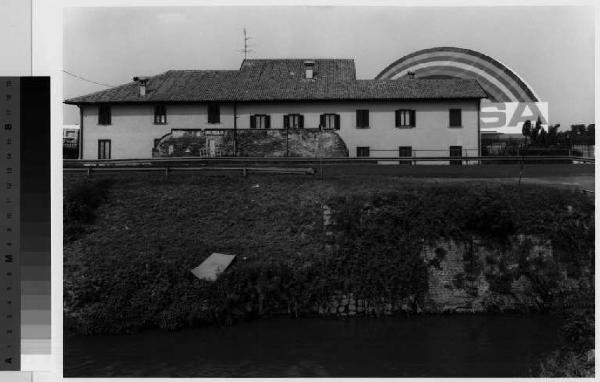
[65,59,487,159]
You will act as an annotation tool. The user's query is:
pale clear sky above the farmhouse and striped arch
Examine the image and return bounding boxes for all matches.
[63,6,595,129]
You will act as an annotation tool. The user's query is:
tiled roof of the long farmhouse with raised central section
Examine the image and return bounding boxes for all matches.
[65,59,487,104]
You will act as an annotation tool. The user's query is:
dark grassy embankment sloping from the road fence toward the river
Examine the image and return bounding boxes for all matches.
[64,174,594,334]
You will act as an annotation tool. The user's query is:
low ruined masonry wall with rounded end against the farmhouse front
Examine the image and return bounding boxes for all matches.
[153,129,348,158]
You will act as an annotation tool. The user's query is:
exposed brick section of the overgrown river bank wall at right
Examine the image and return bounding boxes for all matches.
[423,235,553,312]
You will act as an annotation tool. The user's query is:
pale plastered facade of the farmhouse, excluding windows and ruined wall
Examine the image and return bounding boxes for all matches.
[80,99,479,159]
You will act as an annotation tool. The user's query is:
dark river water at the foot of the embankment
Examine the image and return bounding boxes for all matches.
[64,315,561,377]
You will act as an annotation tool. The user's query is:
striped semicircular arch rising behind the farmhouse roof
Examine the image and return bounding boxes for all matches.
[376,47,539,102]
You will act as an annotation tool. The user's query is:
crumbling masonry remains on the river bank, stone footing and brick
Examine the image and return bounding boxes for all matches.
[315,205,586,316]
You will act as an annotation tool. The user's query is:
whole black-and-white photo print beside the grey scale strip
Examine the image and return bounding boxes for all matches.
[54,4,598,378]
